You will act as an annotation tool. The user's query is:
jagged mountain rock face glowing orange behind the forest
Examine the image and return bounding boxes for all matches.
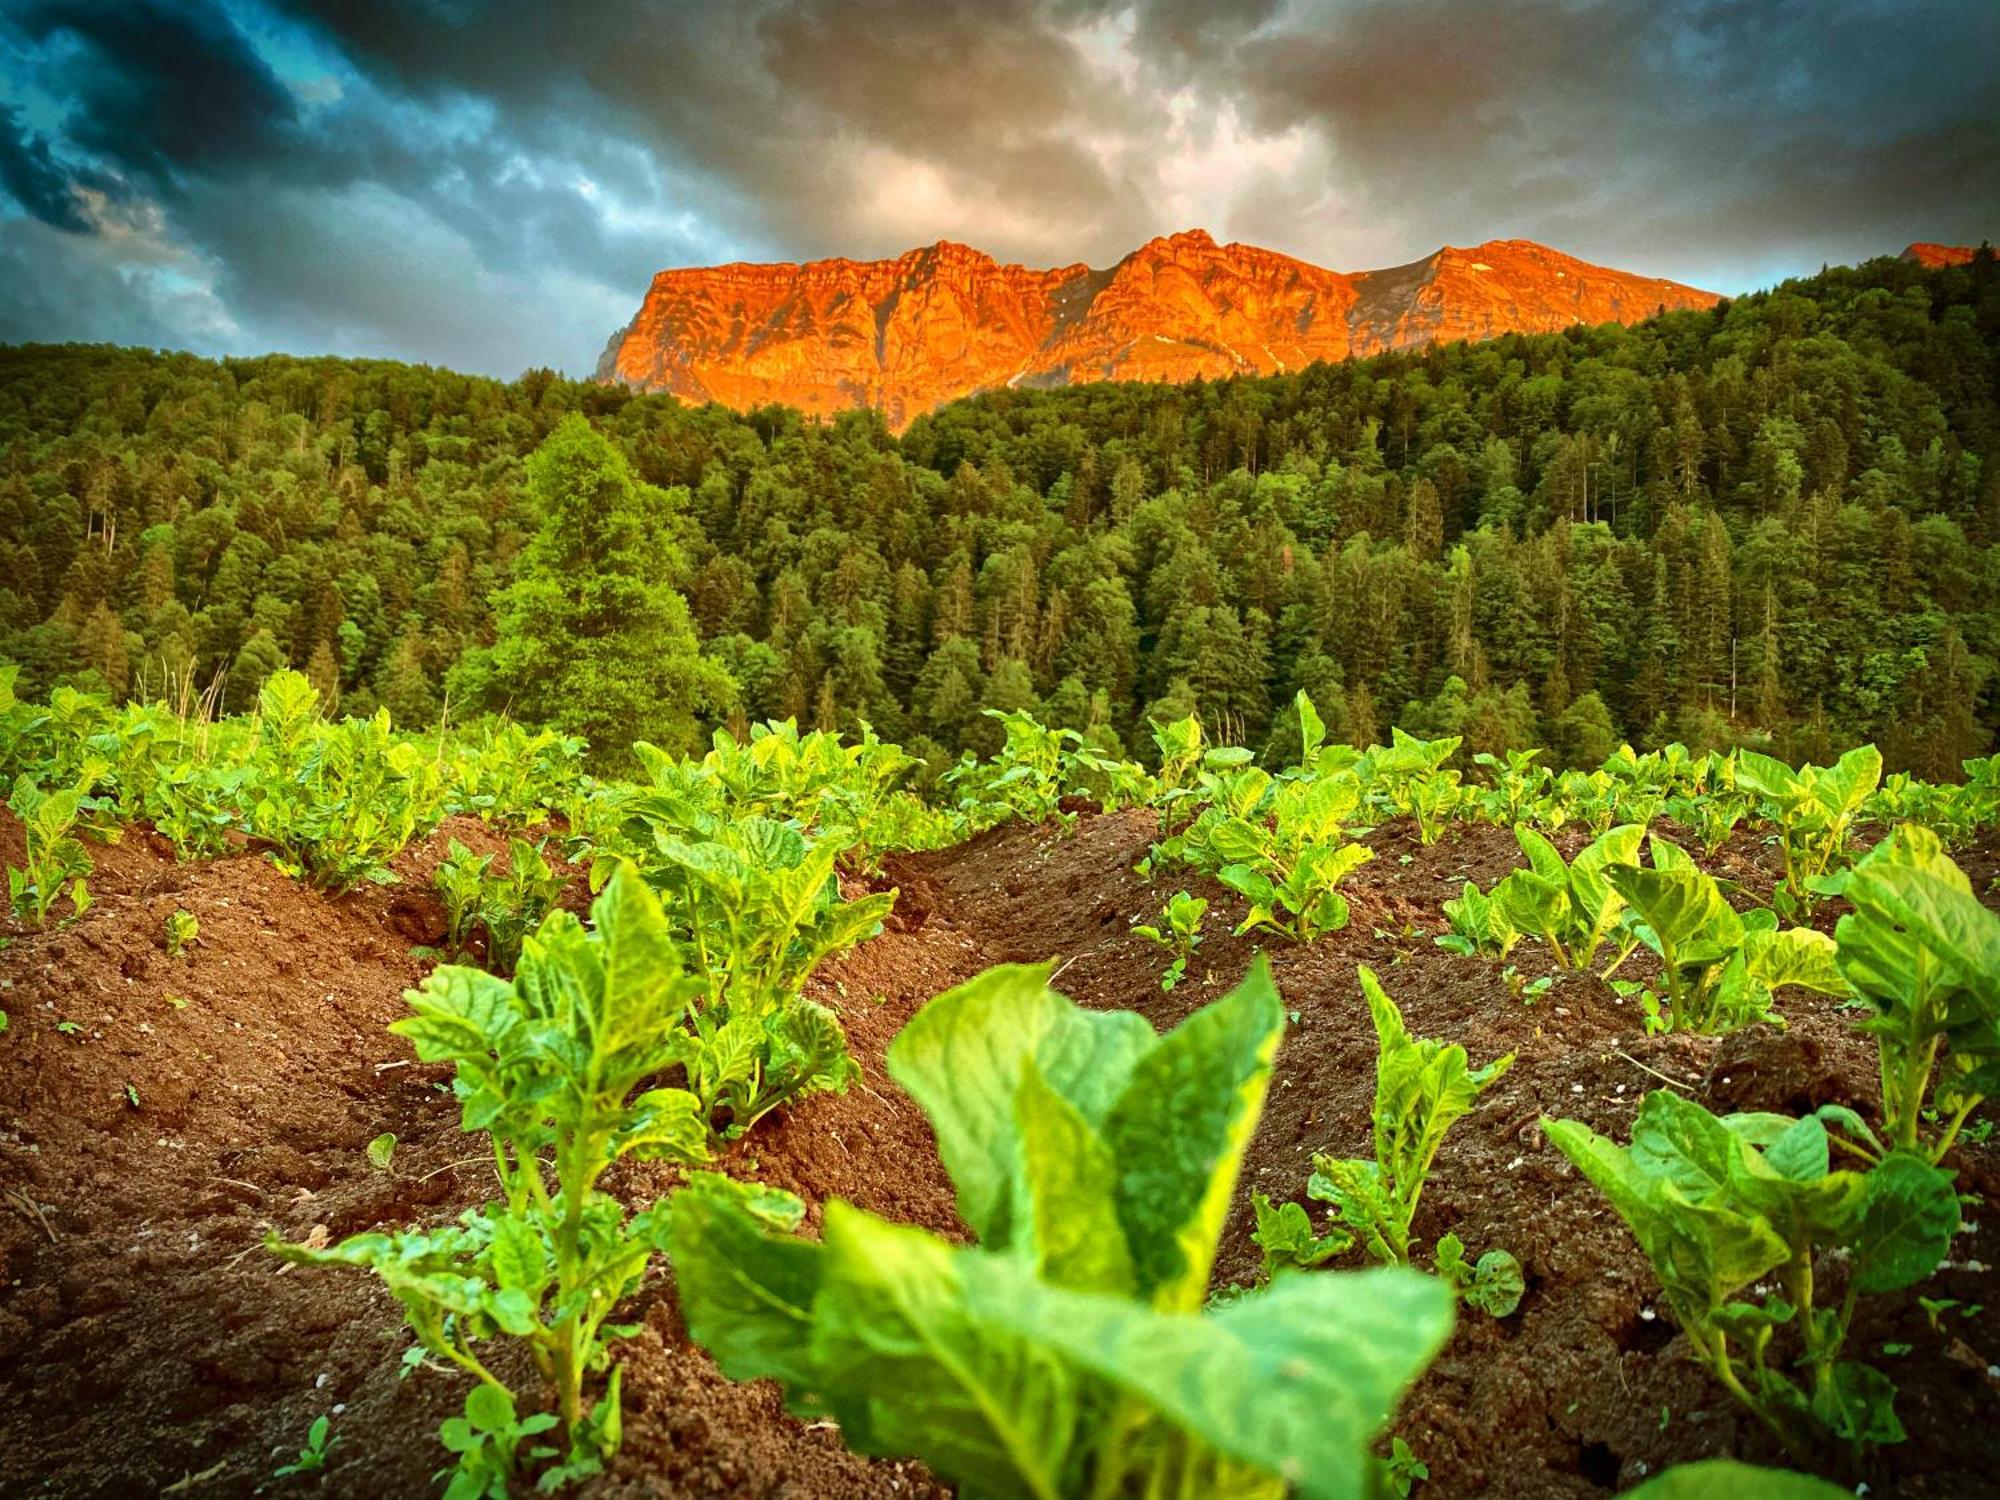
[598,230,1718,428]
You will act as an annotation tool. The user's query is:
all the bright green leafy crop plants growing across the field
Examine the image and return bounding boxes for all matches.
[0,672,2000,1500]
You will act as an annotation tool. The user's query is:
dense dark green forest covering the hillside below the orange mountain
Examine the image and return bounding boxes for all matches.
[0,252,2000,776]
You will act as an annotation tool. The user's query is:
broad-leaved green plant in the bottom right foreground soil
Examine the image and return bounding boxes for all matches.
[1544,1090,1958,1464]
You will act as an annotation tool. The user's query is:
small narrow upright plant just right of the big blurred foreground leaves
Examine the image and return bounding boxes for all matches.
[1306,964,1514,1266]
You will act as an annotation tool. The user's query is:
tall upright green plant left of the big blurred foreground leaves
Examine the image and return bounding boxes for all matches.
[268,868,708,1500]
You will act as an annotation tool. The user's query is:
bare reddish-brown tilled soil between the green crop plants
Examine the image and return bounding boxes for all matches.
[0,812,2000,1500]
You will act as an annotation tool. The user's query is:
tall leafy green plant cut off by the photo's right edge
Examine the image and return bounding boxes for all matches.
[1820,824,2000,1162]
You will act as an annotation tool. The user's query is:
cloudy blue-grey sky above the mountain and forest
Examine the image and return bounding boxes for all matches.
[0,0,2000,376]
